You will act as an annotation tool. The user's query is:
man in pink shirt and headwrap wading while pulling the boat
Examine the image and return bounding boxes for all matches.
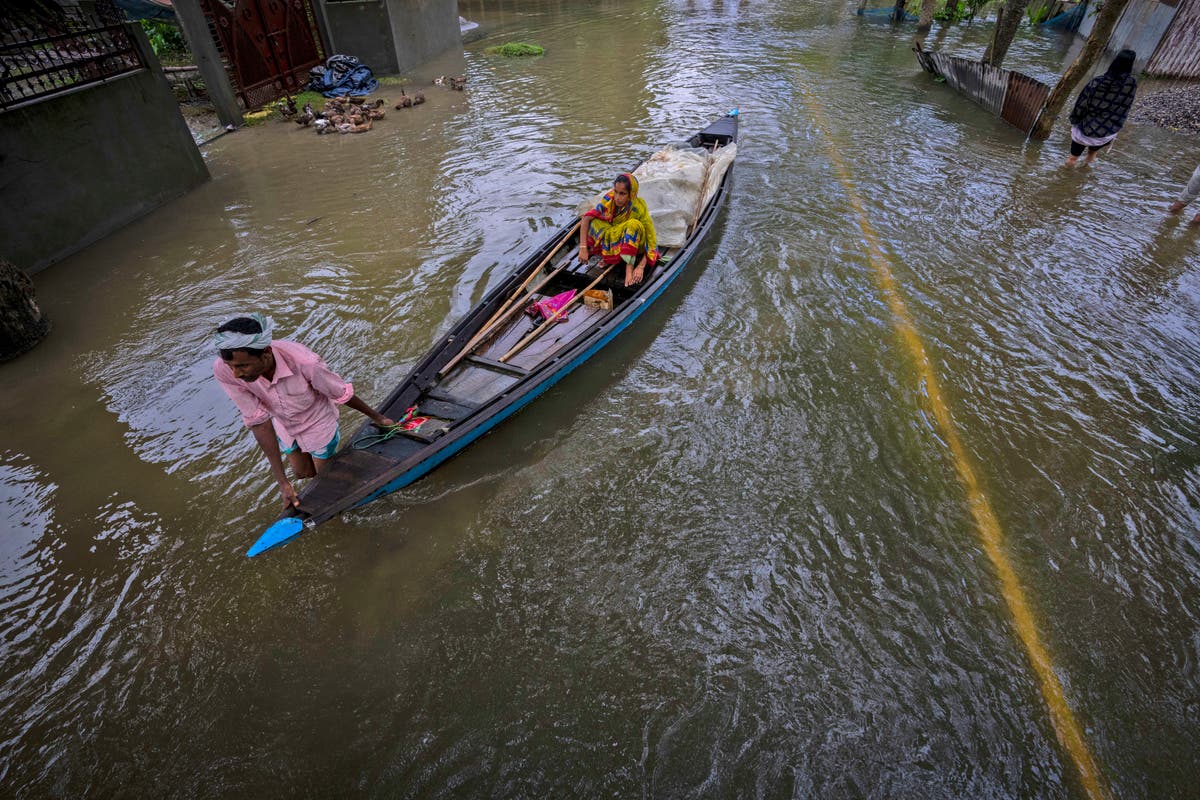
[212,314,396,509]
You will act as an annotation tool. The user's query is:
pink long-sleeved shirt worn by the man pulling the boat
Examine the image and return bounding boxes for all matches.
[212,342,354,452]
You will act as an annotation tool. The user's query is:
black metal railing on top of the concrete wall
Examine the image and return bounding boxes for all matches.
[0,0,145,110]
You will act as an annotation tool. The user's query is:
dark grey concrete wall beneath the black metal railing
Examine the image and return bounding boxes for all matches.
[0,31,209,272]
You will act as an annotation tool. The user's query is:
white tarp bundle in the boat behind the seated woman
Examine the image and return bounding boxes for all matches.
[578,143,737,248]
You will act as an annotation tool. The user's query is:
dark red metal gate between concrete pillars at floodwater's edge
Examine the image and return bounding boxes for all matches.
[200,0,325,110]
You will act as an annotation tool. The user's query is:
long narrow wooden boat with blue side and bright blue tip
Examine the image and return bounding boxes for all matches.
[247,110,738,555]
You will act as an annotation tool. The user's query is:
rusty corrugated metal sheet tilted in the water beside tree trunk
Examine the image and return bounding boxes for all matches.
[917,49,1051,133]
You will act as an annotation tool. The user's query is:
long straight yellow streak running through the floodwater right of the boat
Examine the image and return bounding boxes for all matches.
[798,82,1109,800]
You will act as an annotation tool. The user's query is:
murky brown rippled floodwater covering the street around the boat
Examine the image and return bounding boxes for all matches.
[0,0,1200,798]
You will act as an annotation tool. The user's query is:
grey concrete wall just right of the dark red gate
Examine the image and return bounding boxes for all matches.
[320,0,462,74]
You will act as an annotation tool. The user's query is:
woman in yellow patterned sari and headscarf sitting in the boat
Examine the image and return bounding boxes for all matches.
[580,173,659,287]
